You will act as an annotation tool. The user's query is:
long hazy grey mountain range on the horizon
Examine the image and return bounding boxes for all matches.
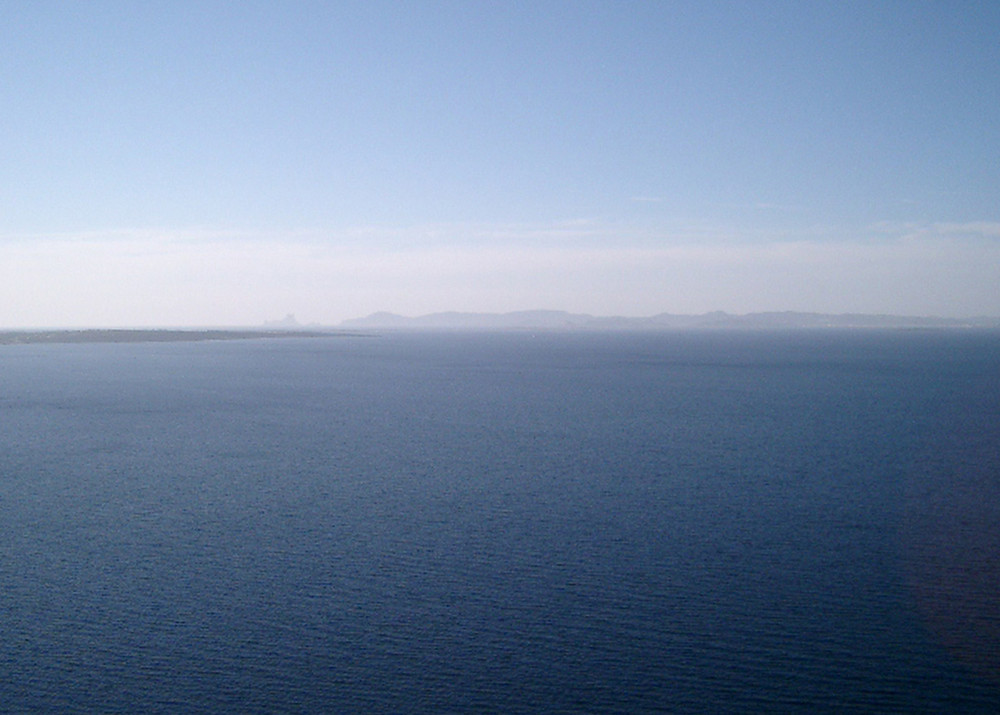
[339,310,1000,330]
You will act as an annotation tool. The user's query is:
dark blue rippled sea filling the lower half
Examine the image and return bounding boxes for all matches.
[0,332,1000,713]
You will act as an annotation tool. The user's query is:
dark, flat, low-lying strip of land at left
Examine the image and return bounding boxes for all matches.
[0,328,356,345]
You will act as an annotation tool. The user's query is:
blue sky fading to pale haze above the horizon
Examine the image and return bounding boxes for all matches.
[0,0,1000,328]
